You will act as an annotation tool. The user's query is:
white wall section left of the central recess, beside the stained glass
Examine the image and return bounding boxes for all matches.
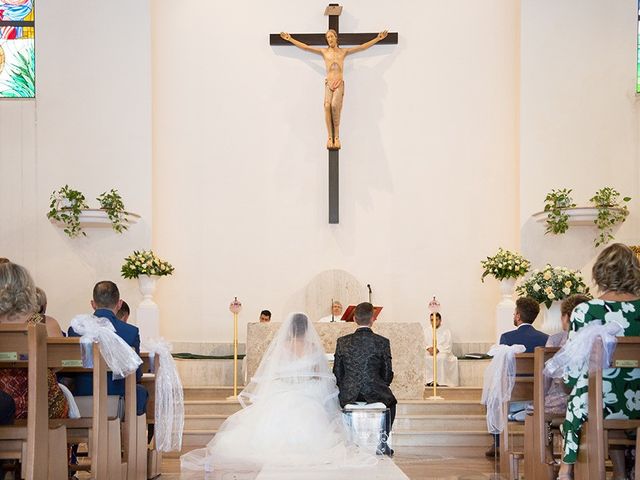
[0,0,152,327]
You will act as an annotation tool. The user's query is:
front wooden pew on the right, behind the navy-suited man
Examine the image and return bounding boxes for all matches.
[500,353,534,480]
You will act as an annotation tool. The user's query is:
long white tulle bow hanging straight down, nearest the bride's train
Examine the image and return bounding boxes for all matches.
[145,338,184,452]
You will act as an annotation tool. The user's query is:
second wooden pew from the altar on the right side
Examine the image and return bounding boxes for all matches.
[524,347,564,480]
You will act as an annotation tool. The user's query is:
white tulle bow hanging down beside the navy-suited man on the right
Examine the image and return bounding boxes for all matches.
[482,345,526,433]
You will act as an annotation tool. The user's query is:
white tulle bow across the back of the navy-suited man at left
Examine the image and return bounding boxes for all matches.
[71,314,142,380]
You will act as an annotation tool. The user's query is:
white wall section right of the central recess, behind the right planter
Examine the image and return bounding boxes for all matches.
[520,0,640,280]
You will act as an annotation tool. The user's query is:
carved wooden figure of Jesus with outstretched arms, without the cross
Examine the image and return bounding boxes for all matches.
[280,30,387,150]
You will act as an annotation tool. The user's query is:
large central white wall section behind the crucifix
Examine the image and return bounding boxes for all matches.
[152,0,519,341]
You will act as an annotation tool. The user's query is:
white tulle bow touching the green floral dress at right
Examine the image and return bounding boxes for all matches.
[544,321,623,378]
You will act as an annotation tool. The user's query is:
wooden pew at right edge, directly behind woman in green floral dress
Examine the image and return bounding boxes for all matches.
[574,337,640,480]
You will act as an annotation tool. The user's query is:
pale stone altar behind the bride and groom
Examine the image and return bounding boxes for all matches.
[246,322,426,400]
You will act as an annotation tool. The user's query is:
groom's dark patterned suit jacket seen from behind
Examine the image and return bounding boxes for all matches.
[333,328,397,407]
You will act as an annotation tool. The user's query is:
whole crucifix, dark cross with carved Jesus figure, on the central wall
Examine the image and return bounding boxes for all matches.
[269,3,398,224]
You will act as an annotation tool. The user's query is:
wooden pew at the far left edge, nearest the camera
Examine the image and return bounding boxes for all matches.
[0,324,67,480]
